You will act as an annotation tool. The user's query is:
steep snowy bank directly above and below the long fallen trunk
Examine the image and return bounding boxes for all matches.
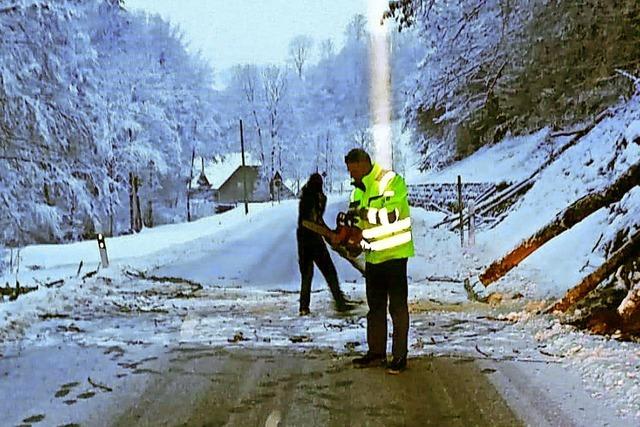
[476,98,640,297]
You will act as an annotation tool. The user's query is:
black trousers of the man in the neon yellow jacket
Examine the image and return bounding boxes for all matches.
[365,258,409,358]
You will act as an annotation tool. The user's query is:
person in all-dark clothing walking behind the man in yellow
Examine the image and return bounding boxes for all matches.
[296,173,353,316]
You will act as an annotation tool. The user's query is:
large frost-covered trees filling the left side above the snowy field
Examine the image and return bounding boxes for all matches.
[0,0,225,245]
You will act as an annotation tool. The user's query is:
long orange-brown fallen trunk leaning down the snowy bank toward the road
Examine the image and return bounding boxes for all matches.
[479,162,640,286]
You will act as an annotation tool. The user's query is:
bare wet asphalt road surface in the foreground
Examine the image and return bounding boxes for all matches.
[112,347,522,427]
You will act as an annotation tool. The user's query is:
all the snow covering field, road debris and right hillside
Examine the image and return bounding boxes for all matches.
[0,95,640,425]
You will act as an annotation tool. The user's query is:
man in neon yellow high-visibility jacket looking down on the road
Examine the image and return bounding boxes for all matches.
[345,148,414,374]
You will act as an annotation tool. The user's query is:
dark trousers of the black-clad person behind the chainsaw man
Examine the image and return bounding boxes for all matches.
[296,228,344,310]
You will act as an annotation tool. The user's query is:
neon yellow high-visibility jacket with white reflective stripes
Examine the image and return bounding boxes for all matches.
[349,163,414,264]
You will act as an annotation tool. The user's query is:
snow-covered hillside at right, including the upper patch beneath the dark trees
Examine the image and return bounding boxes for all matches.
[413,96,640,298]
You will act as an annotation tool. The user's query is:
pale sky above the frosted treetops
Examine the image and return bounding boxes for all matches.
[125,0,368,71]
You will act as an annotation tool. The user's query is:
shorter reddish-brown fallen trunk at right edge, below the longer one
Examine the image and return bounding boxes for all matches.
[547,230,640,313]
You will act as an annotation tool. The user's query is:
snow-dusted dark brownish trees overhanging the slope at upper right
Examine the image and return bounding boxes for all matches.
[387,0,640,171]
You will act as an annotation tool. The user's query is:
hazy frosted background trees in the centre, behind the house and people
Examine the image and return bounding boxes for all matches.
[221,11,422,189]
